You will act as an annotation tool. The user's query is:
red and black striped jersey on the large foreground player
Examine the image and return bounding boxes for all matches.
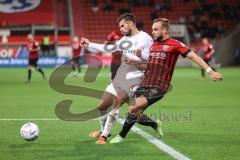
[141,38,191,93]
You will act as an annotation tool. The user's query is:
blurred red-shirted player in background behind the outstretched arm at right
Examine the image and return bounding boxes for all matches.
[200,38,215,80]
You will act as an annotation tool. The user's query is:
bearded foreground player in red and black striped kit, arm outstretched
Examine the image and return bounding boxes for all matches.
[110,18,222,143]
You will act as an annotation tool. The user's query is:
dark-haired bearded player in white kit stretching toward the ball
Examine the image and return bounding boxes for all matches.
[81,13,161,144]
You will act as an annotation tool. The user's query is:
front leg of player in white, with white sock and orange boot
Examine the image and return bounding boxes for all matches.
[96,90,129,144]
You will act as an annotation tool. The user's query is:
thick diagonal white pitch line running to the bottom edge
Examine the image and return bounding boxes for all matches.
[118,119,191,160]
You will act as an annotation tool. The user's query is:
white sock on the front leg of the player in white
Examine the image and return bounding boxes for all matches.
[101,108,120,137]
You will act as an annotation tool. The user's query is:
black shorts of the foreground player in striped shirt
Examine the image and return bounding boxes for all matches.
[135,86,164,106]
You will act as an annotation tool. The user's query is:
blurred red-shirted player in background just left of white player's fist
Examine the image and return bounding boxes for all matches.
[71,36,81,76]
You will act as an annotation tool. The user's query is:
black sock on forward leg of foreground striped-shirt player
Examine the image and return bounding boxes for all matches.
[119,113,137,138]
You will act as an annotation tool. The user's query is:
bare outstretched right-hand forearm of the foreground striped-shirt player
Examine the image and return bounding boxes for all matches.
[187,51,223,80]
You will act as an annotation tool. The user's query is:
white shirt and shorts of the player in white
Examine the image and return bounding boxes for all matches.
[89,31,153,97]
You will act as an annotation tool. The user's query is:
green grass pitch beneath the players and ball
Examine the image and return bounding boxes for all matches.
[0,68,240,160]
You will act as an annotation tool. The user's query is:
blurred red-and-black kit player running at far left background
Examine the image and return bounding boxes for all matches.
[26,34,45,83]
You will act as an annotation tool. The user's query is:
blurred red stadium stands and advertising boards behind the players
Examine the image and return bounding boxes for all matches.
[0,0,240,67]
